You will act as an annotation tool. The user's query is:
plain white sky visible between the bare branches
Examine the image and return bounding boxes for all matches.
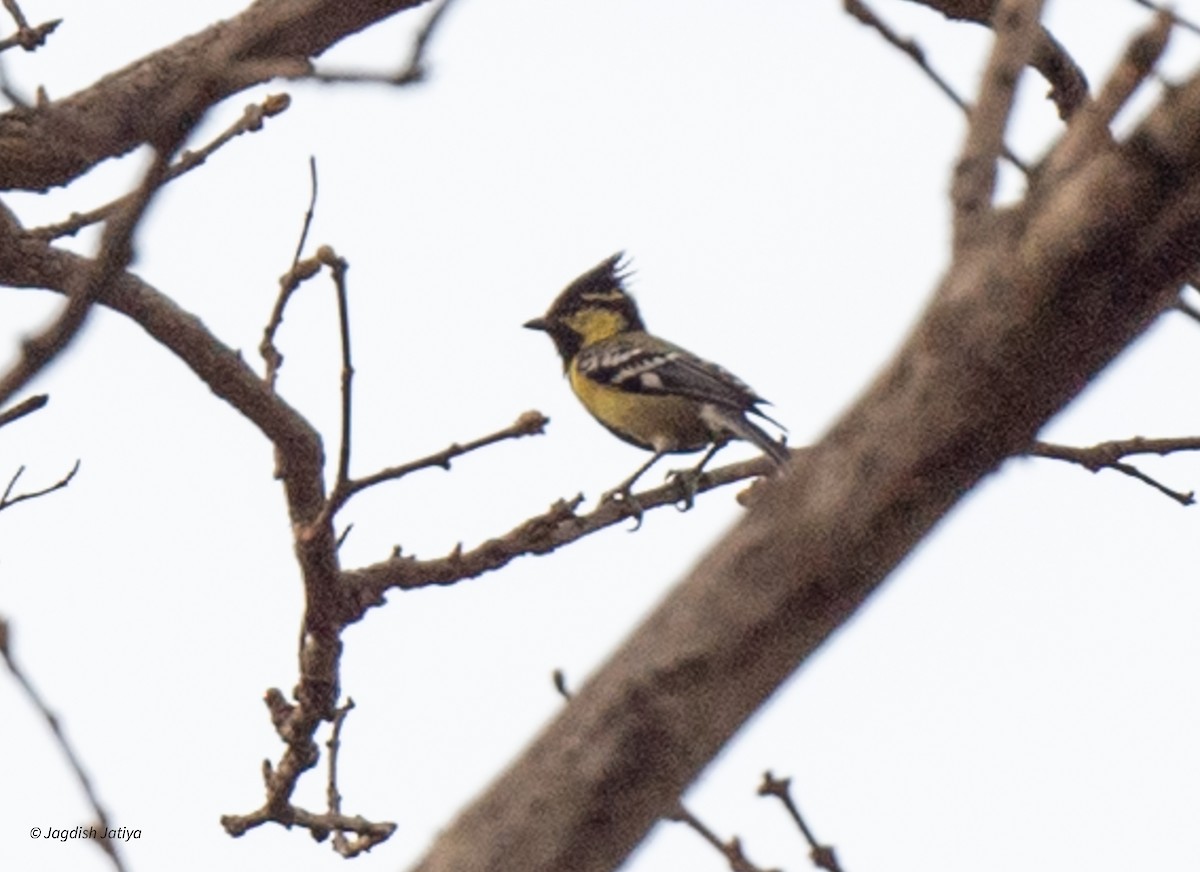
[0,0,1200,872]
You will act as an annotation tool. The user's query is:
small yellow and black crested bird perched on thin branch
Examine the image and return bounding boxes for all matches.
[524,252,790,518]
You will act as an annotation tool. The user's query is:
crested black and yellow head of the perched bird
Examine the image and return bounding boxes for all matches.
[524,252,646,368]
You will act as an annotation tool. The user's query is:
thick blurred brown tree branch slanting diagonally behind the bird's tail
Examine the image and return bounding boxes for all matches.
[415,20,1200,872]
